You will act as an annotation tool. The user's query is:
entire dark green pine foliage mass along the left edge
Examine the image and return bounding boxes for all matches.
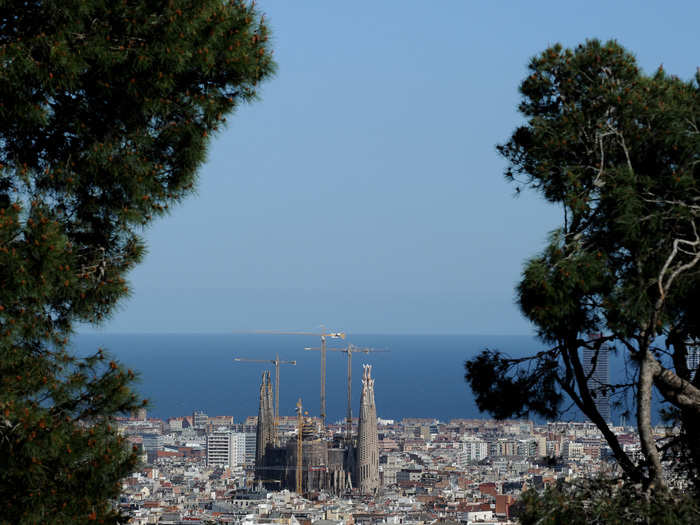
[0,0,274,524]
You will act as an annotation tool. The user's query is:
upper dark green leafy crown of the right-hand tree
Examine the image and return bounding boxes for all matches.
[499,41,700,341]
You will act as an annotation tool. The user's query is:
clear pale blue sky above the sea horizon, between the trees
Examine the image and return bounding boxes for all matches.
[91,0,700,334]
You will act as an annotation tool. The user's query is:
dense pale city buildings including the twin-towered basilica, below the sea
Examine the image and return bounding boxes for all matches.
[112,345,668,525]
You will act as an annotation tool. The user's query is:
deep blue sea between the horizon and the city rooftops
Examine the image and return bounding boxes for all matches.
[72,333,636,422]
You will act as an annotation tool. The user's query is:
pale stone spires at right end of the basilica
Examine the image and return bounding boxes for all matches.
[355,365,379,494]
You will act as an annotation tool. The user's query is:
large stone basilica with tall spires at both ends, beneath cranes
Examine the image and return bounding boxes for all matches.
[255,365,379,494]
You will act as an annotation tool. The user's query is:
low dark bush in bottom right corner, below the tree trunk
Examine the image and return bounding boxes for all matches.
[511,480,700,525]
